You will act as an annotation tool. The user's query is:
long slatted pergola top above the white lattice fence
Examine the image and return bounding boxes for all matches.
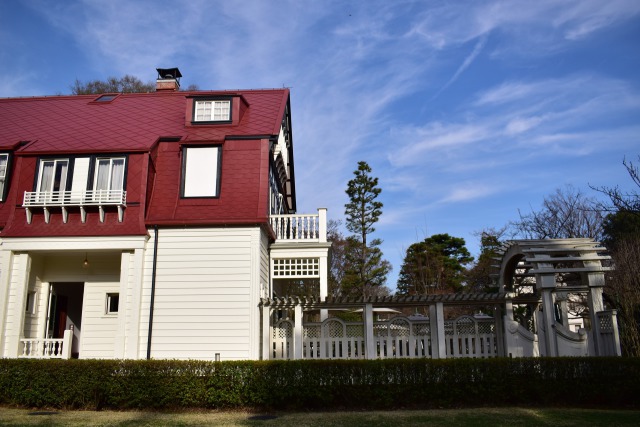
[260,292,540,309]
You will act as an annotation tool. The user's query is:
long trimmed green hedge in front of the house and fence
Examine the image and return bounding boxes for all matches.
[0,358,640,410]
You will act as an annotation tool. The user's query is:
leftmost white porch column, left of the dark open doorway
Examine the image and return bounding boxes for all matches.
[3,253,31,357]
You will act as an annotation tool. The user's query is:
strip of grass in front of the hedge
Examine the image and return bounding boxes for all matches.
[0,408,640,427]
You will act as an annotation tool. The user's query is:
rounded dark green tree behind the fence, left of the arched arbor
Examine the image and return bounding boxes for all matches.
[397,233,473,295]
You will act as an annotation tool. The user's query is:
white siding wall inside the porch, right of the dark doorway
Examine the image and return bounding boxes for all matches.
[80,282,122,359]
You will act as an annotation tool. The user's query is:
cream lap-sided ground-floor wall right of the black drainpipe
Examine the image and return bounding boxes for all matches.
[140,227,260,360]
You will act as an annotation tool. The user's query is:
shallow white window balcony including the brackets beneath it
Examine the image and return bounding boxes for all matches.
[22,190,127,224]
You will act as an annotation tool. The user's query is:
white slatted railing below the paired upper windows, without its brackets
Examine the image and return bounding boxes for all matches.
[22,190,127,207]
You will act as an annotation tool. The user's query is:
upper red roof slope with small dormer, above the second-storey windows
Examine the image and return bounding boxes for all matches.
[0,89,289,155]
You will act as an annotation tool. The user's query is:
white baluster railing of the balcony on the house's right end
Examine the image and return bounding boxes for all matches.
[270,208,327,242]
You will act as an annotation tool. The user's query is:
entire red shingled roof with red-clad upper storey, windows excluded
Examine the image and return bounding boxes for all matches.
[0,89,289,237]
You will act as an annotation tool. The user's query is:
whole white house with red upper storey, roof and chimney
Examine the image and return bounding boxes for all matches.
[0,68,330,360]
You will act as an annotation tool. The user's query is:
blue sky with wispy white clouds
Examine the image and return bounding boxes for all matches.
[0,0,640,288]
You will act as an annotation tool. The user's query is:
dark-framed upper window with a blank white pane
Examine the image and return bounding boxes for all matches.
[181,145,222,198]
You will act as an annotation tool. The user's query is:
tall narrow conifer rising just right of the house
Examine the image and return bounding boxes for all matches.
[342,161,391,297]
